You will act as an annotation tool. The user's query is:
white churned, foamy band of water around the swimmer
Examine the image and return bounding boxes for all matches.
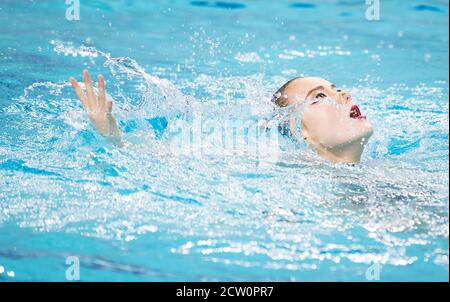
[0,41,449,280]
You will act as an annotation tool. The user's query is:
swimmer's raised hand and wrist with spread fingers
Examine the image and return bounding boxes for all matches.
[70,70,124,147]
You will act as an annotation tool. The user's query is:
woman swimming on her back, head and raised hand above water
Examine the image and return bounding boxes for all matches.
[70,70,373,163]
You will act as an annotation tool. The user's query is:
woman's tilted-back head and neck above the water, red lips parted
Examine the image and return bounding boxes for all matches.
[272,77,373,162]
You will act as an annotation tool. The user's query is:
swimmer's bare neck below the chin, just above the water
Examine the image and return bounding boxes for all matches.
[315,136,370,163]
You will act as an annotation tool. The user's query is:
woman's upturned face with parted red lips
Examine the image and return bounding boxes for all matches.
[285,77,373,159]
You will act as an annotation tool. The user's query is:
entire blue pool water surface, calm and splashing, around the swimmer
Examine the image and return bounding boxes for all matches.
[0,0,449,281]
